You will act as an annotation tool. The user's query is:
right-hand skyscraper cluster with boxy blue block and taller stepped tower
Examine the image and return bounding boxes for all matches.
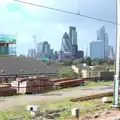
[90,26,114,60]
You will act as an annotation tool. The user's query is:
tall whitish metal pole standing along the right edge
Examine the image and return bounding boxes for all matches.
[113,0,120,108]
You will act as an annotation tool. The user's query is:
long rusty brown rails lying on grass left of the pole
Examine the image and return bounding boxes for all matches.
[70,90,120,102]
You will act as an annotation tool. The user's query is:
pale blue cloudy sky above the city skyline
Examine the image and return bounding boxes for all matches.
[0,0,115,55]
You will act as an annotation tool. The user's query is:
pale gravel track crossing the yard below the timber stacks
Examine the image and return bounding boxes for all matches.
[0,85,113,110]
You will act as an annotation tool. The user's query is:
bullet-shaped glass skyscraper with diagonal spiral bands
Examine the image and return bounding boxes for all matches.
[61,32,72,53]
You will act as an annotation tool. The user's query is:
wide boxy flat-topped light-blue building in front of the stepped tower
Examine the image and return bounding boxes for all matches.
[90,40,104,59]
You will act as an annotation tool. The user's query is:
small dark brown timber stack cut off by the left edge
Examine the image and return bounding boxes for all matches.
[0,85,16,96]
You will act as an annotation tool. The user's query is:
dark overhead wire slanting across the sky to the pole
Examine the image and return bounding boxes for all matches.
[14,0,117,25]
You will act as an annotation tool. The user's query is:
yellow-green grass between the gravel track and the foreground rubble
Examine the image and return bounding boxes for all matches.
[0,99,111,120]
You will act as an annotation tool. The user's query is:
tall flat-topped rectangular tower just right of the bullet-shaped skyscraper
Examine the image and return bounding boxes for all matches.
[69,26,77,45]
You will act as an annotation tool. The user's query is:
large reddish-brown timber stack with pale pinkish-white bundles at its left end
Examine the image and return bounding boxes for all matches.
[11,76,54,93]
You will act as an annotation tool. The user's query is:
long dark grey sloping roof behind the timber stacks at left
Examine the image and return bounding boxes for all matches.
[0,56,56,76]
